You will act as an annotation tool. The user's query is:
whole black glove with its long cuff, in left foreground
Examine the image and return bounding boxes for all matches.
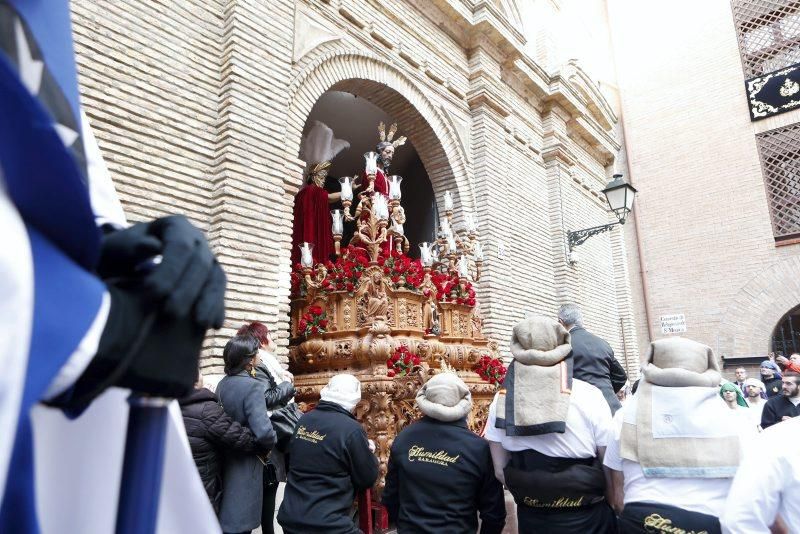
[54,216,225,411]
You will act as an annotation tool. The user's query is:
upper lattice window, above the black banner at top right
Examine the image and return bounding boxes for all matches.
[731,0,800,78]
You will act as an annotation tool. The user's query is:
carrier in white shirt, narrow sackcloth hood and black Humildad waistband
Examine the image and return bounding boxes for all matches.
[486,317,616,534]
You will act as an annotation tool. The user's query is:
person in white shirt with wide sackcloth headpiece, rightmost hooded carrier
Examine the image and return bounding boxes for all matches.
[604,337,756,533]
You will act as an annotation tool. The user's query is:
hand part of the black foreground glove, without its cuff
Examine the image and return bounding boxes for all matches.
[97,215,225,328]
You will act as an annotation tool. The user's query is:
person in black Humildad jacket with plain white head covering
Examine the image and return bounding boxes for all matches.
[278,374,378,534]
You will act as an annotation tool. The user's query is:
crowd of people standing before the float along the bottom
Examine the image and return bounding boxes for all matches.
[181,304,800,534]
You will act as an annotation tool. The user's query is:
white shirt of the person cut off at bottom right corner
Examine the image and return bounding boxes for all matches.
[720,417,800,534]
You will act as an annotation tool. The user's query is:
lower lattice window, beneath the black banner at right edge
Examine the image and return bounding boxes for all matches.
[756,124,800,241]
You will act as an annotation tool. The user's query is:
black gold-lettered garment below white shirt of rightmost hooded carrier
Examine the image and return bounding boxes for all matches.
[619,502,722,534]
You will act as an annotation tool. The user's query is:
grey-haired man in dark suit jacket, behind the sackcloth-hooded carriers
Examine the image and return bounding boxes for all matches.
[558,303,628,415]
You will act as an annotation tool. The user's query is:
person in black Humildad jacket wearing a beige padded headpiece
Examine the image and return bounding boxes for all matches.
[382,372,506,534]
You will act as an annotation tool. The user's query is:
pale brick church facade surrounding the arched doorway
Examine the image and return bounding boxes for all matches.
[72,0,638,372]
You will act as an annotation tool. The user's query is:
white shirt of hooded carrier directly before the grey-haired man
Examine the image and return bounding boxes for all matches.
[486,379,612,458]
